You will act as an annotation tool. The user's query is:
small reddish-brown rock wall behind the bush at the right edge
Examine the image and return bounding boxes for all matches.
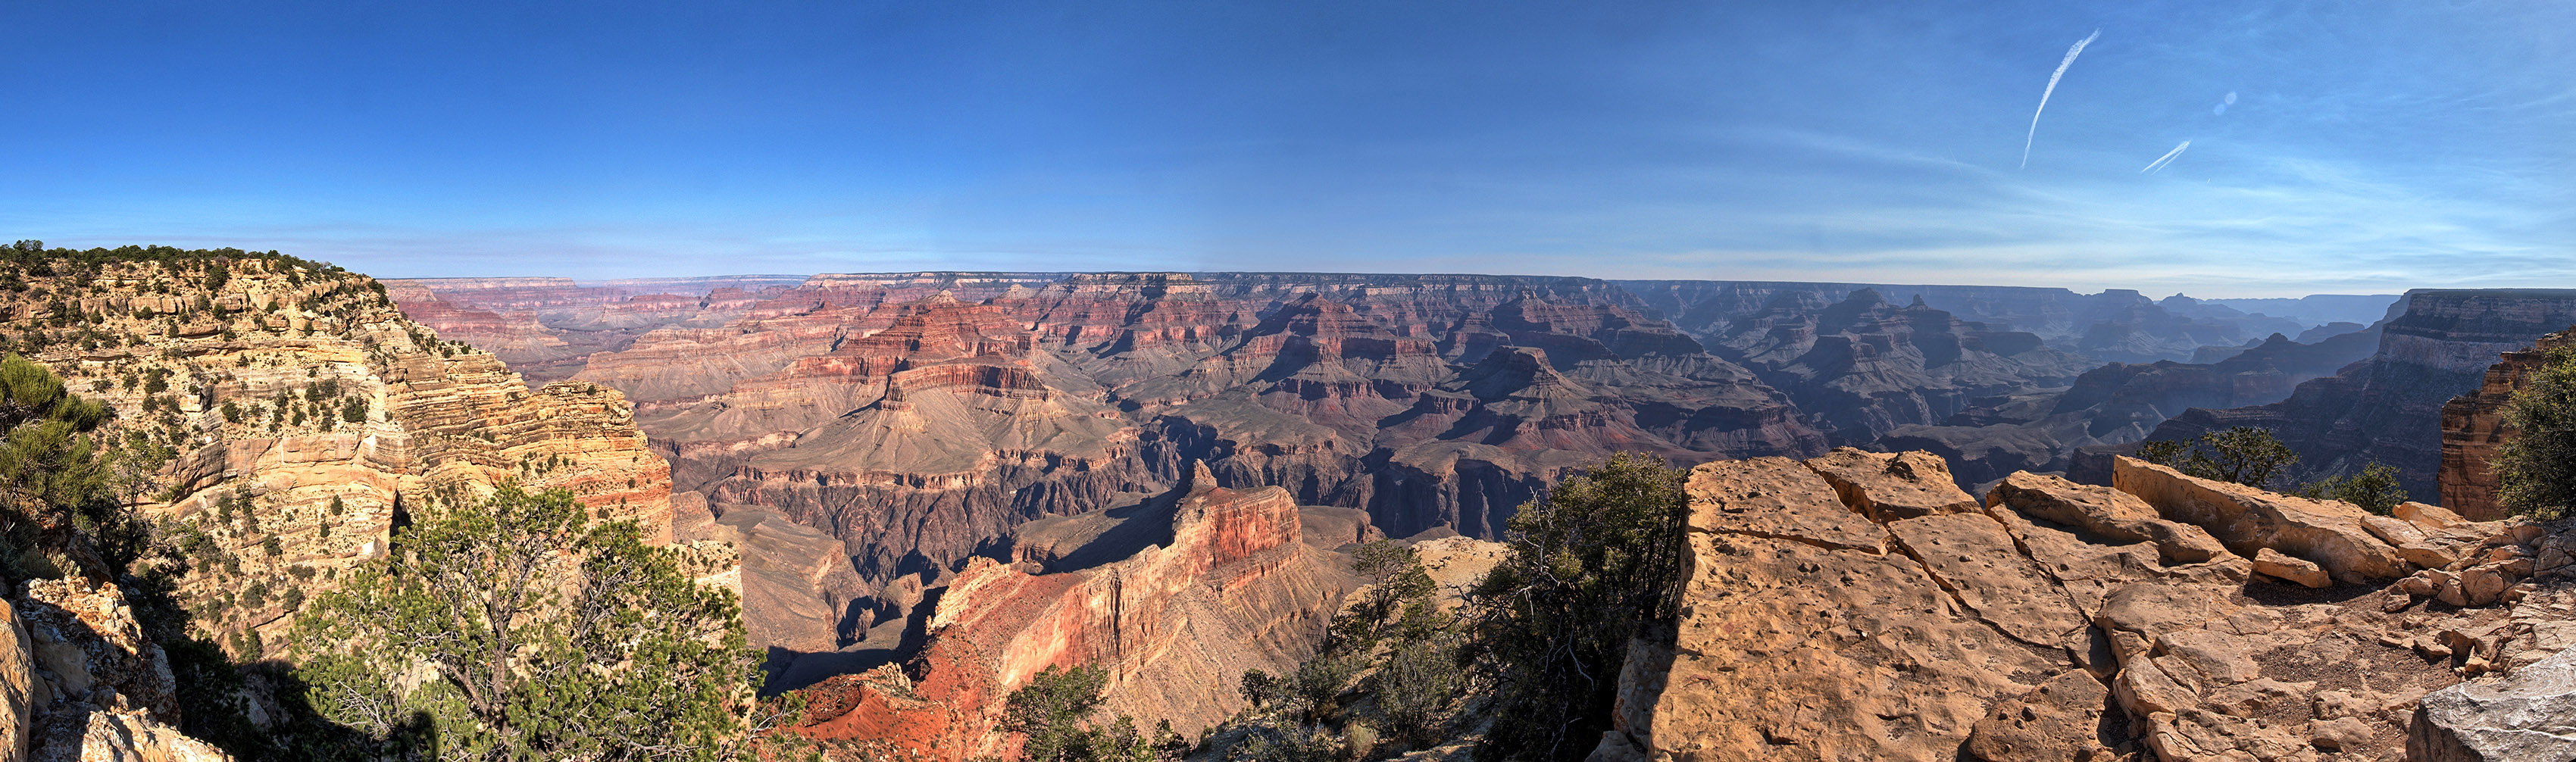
[2440,329,2576,520]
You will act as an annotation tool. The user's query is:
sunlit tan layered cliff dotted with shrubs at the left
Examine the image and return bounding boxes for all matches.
[0,258,672,659]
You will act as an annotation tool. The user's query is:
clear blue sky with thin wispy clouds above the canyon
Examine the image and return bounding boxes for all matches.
[0,0,2576,296]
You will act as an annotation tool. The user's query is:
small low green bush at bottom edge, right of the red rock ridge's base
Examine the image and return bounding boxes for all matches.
[1002,664,1187,762]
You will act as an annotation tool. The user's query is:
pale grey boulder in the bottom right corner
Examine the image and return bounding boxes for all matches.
[2406,648,2576,762]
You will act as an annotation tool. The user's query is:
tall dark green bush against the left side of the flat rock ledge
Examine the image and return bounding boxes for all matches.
[1476,453,1690,760]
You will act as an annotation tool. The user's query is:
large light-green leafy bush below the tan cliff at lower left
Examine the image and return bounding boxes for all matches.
[296,484,758,760]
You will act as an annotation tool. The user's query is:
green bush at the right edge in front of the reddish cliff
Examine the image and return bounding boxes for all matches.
[2496,348,2576,517]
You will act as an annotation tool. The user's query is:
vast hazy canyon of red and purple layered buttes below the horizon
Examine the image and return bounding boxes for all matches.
[389,273,2411,669]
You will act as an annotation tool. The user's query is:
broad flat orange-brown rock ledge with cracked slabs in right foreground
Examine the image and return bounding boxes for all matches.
[1592,453,2576,762]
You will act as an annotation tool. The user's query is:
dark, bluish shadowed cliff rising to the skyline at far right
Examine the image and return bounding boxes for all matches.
[2151,289,2576,497]
